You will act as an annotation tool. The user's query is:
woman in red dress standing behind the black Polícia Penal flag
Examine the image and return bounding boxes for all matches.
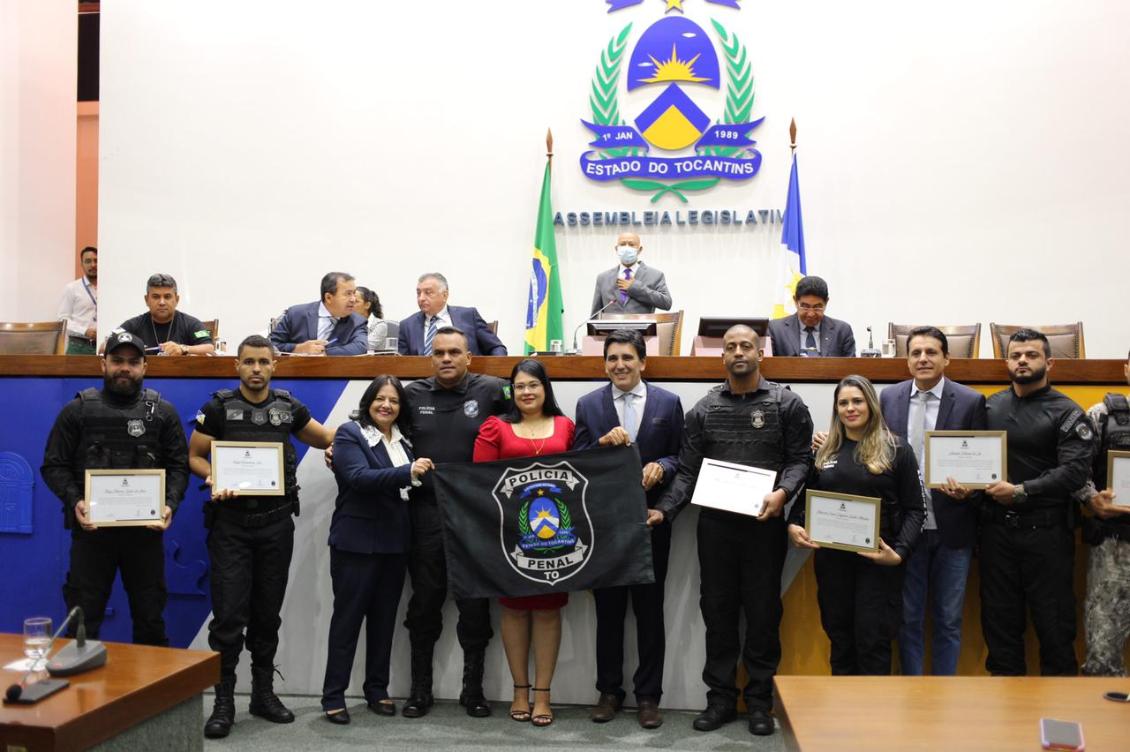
[475,360,575,726]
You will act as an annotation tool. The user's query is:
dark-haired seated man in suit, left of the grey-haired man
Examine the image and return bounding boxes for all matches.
[271,271,368,355]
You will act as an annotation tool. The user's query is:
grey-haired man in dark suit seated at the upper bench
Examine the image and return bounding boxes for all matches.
[397,271,506,355]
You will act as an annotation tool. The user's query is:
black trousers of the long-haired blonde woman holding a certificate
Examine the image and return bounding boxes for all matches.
[815,548,904,676]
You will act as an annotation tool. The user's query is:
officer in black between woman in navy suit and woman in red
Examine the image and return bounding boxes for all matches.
[402,327,509,718]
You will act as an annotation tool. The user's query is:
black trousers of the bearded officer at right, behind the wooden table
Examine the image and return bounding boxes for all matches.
[981,522,1079,676]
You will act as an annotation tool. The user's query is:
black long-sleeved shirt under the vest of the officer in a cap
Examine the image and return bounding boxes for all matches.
[40,389,189,520]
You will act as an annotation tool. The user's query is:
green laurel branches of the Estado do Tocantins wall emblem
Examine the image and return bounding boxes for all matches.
[589,19,754,204]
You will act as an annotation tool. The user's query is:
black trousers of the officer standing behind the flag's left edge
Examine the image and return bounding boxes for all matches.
[405,515,494,652]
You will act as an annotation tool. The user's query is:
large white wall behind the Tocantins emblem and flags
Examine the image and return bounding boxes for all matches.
[99,0,1130,357]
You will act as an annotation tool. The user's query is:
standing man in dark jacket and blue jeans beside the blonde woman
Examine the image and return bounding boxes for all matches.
[879,327,985,675]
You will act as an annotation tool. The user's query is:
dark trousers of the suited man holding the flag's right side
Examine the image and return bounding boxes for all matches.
[592,515,671,702]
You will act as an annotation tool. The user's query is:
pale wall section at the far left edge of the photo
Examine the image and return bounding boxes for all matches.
[0,0,78,321]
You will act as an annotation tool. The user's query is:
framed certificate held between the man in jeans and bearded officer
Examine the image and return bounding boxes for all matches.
[922,431,1008,489]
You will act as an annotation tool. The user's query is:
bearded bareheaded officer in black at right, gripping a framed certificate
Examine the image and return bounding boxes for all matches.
[981,329,1094,676]
